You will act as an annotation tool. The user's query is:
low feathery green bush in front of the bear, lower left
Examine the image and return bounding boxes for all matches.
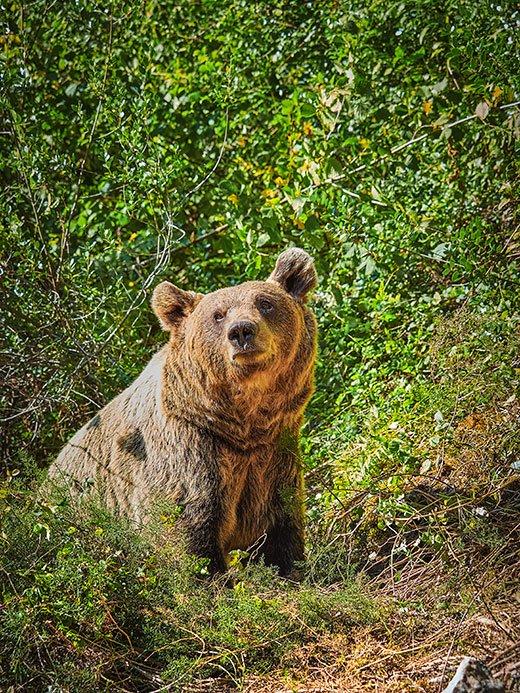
[0,484,378,691]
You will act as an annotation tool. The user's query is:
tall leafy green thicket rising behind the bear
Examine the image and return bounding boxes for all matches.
[0,0,518,476]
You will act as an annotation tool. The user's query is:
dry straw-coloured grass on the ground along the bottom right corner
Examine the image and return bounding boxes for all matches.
[189,580,520,693]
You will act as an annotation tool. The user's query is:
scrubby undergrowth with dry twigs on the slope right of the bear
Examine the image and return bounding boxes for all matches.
[309,307,520,577]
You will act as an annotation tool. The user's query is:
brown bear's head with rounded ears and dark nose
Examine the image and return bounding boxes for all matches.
[152,248,317,381]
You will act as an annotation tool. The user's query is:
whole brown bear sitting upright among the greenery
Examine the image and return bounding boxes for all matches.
[50,248,316,575]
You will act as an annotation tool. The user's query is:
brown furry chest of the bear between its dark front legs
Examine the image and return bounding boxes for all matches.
[220,448,277,552]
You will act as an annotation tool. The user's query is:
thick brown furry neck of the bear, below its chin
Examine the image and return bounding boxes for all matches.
[161,351,313,452]
